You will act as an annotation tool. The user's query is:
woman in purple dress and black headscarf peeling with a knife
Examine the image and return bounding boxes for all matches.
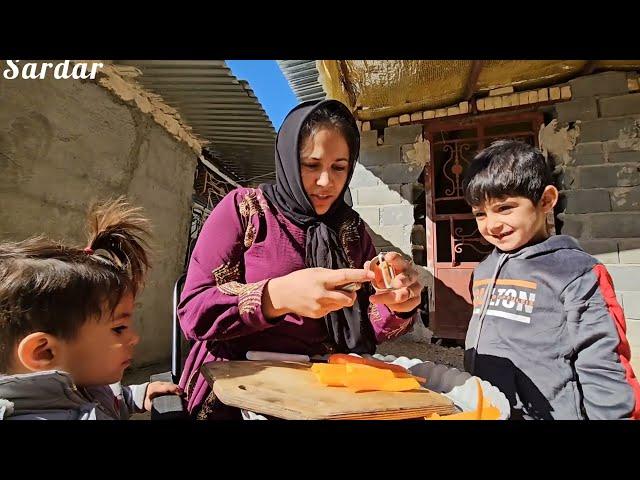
[178,100,422,419]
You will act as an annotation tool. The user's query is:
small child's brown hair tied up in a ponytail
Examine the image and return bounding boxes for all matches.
[0,197,149,372]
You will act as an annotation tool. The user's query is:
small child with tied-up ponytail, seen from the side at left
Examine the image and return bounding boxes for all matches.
[0,199,180,420]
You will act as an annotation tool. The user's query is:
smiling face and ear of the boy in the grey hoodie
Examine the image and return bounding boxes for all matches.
[472,186,558,252]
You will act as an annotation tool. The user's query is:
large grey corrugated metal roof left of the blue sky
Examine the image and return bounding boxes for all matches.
[114,60,276,183]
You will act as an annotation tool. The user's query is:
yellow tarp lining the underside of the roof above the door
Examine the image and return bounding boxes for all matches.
[317,60,640,120]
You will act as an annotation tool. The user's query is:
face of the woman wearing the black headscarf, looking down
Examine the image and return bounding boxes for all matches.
[300,128,349,215]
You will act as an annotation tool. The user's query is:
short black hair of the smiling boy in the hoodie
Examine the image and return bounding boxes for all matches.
[462,140,553,207]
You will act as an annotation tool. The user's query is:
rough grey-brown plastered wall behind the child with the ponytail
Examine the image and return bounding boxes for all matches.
[0,74,196,365]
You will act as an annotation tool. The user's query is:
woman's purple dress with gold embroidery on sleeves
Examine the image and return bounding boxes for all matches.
[179,188,415,412]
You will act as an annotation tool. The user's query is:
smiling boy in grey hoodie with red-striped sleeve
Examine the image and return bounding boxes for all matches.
[463,140,640,419]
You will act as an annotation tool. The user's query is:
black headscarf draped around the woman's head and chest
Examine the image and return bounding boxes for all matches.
[260,100,375,353]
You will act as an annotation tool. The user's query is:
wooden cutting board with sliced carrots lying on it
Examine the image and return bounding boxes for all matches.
[202,361,456,420]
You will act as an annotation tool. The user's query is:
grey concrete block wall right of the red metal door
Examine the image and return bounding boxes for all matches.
[555,72,640,373]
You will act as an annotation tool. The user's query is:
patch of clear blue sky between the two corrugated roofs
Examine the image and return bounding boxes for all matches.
[226,60,298,131]
